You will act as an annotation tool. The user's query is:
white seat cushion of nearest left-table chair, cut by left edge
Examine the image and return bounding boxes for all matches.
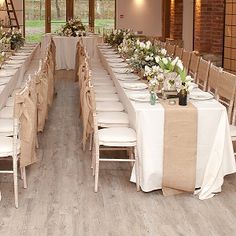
[0,136,20,157]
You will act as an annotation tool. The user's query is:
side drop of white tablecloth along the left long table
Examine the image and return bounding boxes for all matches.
[0,45,40,109]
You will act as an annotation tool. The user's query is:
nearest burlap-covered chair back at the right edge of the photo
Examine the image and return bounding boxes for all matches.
[217,71,236,122]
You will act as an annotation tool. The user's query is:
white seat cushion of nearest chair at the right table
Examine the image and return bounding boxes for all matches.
[98,127,136,146]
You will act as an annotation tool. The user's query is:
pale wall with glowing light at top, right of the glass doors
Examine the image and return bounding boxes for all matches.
[116,0,162,36]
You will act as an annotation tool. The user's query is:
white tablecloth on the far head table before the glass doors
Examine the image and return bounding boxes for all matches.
[42,34,102,70]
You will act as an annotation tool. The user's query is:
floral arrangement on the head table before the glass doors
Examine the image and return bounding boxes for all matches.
[56,18,86,37]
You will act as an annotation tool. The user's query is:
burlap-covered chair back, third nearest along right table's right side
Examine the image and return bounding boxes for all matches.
[196,58,211,91]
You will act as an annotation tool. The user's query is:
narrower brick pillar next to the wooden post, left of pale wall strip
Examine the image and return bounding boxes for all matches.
[170,0,183,39]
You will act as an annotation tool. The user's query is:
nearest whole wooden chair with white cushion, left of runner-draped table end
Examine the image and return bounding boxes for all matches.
[87,82,140,192]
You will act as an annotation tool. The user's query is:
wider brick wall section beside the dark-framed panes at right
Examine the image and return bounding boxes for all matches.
[194,0,224,55]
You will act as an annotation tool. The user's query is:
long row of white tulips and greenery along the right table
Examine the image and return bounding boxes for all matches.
[104,29,192,95]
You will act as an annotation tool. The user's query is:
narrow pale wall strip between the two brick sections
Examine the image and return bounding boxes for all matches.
[183,0,193,51]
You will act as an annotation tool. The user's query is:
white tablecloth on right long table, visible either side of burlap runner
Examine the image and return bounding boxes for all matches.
[99,50,236,199]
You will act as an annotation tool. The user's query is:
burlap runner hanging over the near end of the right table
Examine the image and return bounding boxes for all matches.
[161,101,197,196]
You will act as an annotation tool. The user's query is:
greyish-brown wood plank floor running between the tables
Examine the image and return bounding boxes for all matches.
[0,71,236,236]
